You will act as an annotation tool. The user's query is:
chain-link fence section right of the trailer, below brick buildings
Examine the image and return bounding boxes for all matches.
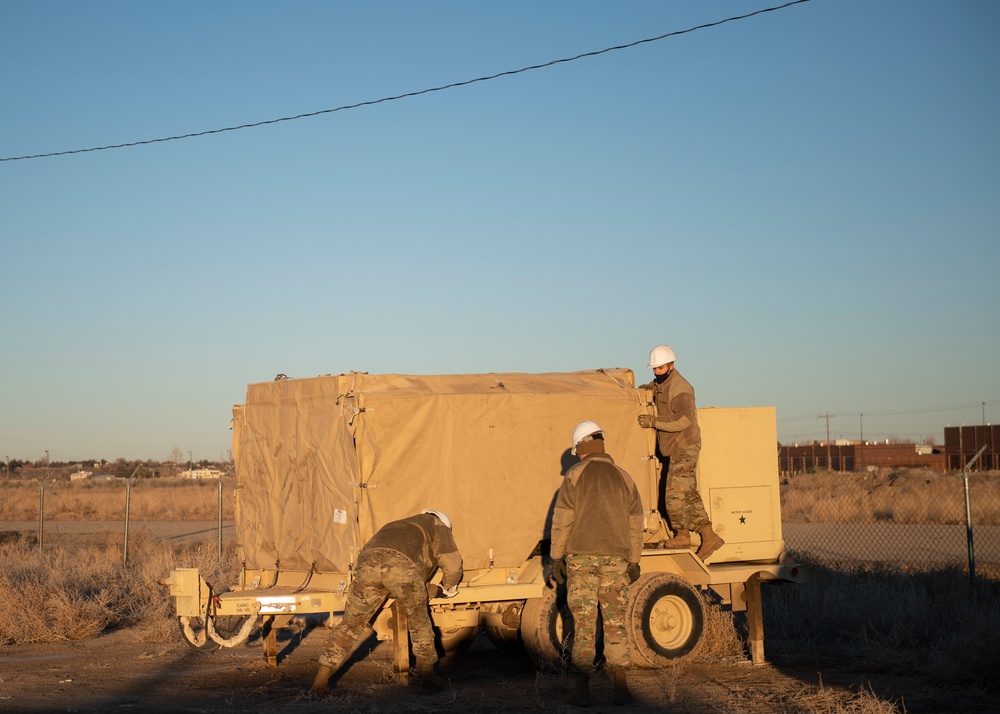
[781,469,1000,575]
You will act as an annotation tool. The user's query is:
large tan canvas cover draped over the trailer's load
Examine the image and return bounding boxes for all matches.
[233,369,656,572]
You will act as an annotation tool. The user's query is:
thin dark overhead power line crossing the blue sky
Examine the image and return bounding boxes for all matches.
[0,0,811,161]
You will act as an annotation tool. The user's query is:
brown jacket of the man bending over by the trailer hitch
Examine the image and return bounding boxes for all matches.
[362,513,462,590]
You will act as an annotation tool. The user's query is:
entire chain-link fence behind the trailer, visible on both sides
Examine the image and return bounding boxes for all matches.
[7,469,1000,573]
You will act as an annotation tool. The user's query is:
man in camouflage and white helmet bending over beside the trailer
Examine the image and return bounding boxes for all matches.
[312,509,462,694]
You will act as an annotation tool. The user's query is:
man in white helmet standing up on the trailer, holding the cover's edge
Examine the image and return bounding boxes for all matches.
[639,345,725,560]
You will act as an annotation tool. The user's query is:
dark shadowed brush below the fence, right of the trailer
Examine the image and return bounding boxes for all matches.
[764,564,1000,688]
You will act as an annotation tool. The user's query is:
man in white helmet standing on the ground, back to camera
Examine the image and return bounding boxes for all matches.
[549,421,643,706]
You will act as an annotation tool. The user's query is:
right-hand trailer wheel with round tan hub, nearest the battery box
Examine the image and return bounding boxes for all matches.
[627,573,705,667]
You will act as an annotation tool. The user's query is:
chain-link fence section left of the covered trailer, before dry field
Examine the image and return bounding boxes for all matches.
[0,472,236,561]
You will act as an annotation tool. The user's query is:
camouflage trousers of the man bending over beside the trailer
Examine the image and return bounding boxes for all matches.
[319,548,438,670]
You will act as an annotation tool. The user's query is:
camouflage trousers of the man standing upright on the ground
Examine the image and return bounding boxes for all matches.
[566,555,629,673]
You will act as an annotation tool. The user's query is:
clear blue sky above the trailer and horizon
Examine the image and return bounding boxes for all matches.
[0,0,1000,461]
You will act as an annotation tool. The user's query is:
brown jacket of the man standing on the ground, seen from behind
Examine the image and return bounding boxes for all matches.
[549,454,642,563]
